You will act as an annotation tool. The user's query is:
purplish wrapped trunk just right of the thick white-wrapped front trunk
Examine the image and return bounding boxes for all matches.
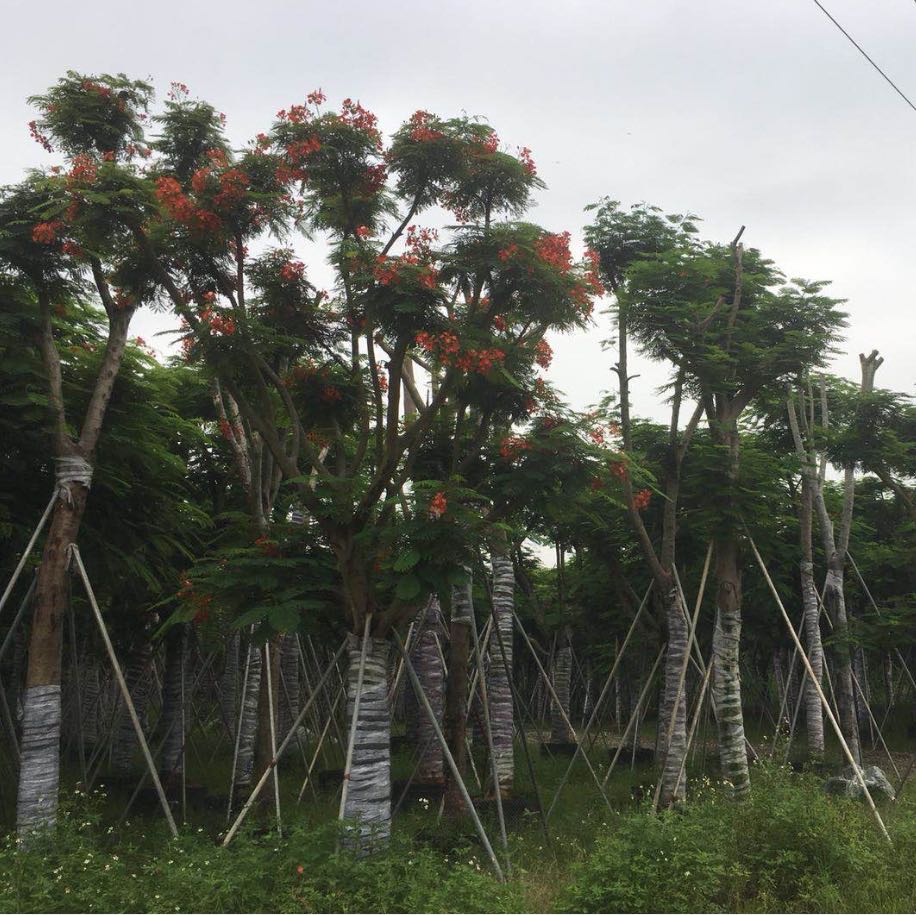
[407,597,445,785]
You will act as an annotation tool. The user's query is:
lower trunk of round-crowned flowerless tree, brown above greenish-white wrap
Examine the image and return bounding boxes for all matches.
[712,536,751,798]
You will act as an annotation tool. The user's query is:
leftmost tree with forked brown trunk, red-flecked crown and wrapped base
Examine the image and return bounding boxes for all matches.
[0,73,152,834]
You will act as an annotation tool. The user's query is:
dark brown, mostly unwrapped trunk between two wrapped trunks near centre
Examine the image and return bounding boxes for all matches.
[445,570,474,816]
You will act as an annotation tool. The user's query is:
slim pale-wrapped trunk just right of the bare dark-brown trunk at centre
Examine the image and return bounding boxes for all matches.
[487,553,515,796]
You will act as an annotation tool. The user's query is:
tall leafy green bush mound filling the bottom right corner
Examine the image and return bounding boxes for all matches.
[561,768,916,912]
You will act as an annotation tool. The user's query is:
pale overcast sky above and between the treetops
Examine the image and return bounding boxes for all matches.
[0,0,916,416]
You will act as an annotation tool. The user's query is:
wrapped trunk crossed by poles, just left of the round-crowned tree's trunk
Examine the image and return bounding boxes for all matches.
[659,582,690,807]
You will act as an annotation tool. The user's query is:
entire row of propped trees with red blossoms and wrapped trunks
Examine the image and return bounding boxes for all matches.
[0,73,916,860]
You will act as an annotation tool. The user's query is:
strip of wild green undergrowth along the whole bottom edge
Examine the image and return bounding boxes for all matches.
[0,766,916,912]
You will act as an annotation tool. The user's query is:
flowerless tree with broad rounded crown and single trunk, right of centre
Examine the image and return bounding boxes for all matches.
[622,220,844,797]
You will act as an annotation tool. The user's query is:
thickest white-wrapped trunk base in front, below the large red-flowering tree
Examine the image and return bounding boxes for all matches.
[343,633,391,855]
